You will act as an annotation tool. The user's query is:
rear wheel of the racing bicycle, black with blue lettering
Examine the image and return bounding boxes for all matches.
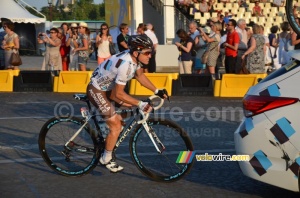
[38,117,100,177]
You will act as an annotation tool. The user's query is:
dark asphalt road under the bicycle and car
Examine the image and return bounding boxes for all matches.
[0,92,299,198]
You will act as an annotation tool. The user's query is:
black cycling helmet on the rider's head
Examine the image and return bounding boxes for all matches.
[128,35,153,52]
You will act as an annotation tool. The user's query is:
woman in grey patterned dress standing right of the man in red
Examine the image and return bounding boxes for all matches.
[242,25,265,74]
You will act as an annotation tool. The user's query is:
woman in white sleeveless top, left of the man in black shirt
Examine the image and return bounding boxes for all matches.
[96,23,113,65]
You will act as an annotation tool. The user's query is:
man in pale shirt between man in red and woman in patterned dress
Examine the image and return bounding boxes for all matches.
[235,19,248,74]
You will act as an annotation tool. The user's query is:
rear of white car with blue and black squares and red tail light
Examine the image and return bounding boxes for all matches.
[234,53,300,191]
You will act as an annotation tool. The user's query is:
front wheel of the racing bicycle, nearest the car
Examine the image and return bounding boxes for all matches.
[129,118,195,182]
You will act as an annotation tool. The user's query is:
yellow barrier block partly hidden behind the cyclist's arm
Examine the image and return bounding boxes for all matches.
[129,73,178,96]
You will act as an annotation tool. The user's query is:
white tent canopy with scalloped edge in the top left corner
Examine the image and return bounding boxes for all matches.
[0,0,46,23]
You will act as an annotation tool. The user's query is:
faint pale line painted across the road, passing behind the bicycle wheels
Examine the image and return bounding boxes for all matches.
[0,149,235,164]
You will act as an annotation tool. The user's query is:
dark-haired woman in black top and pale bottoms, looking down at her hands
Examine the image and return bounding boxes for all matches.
[175,29,193,74]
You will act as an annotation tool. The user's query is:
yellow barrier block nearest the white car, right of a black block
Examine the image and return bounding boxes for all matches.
[214,74,267,97]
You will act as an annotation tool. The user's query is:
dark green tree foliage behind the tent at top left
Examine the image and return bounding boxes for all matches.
[26,0,105,21]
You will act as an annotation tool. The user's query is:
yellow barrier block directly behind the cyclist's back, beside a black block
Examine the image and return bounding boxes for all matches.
[53,71,93,93]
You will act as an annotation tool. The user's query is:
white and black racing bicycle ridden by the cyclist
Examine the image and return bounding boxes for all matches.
[38,94,194,182]
